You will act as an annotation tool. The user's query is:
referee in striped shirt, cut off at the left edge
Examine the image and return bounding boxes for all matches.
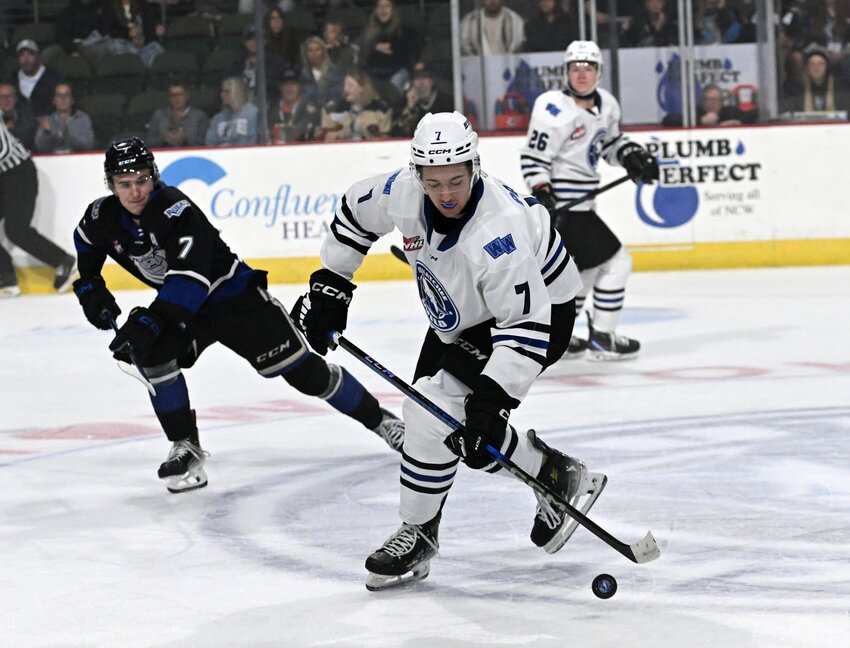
[0,111,77,297]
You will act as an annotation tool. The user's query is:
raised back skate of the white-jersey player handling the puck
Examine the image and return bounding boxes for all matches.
[528,430,608,553]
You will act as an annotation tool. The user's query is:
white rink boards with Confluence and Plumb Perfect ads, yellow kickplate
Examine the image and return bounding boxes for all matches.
[8,124,850,292]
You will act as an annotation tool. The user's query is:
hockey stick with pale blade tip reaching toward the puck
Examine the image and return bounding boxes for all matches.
[329,331,661,563]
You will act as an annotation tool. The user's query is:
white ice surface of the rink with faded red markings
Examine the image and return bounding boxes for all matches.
[0,267,850,648]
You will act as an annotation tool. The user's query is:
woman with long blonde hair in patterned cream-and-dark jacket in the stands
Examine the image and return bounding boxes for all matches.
[320,70,392,142]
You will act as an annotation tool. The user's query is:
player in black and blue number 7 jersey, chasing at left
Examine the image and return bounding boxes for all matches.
[74,137,404,492]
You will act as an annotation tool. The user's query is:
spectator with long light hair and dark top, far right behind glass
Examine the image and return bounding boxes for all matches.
[783,45,850,113]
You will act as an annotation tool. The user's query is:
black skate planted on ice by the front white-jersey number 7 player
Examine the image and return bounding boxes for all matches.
[366,513,440,592]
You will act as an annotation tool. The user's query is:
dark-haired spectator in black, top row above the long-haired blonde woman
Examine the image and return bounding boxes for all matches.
[357,0,416,90]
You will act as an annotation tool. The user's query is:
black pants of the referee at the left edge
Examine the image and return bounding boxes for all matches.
[0,159,67,277]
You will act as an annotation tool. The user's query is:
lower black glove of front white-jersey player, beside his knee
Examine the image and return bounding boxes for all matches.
[443,375,519,470]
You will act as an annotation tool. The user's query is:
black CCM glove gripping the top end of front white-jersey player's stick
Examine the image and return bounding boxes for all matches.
[291,268,357,355]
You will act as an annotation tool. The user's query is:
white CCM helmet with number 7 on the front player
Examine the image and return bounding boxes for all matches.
[410,110,481,184]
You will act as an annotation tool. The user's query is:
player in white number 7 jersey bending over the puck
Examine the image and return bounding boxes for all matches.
[293,112,604,589]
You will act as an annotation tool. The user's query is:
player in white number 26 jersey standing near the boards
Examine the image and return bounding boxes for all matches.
[520,41,658,360]
